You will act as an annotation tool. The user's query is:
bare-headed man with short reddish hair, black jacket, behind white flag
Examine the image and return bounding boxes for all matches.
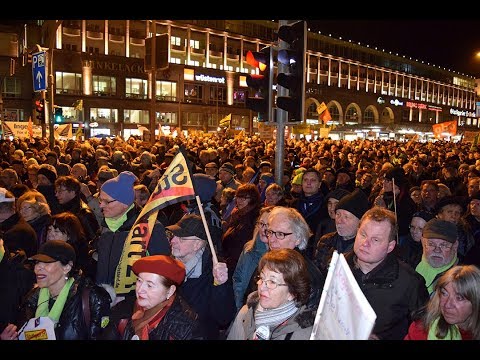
[345,206,428,340]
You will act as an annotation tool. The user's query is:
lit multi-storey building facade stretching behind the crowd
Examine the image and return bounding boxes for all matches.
[0,20,480,138]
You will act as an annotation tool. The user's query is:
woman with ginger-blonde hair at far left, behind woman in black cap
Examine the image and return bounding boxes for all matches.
[16,190,52,249]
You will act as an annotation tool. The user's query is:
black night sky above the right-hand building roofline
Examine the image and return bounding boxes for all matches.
[307,19,480,77]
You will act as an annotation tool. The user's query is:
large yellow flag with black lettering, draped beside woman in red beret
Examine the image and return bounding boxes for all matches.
[114,149,195,295]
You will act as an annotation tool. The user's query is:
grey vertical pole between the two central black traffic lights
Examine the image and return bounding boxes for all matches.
[270,20,288,186]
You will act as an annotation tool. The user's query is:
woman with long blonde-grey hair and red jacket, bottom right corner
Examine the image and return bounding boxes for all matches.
[405,265,480,340]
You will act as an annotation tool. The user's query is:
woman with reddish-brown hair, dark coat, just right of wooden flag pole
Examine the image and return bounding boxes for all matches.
[222,184,260,277]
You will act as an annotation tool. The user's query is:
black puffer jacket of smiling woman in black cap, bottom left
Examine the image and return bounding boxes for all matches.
[17,275,111,340]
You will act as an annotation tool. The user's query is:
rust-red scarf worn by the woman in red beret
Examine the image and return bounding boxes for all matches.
[132,294,175,340]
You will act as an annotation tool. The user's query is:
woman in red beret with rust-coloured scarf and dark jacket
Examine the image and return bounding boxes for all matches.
[102,255,203,340]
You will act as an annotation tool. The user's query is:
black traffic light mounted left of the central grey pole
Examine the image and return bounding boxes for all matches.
[245,46,273,122]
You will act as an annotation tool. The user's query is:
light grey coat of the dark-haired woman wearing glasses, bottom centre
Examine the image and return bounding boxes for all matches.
[227,292,316,340]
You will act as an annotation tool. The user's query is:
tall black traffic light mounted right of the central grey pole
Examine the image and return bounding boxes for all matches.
[277,21,307,122]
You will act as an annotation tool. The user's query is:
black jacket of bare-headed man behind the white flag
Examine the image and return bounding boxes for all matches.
[345,251,429,340]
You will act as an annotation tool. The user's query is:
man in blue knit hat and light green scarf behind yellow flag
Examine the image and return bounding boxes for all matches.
[95,171,170,296]
